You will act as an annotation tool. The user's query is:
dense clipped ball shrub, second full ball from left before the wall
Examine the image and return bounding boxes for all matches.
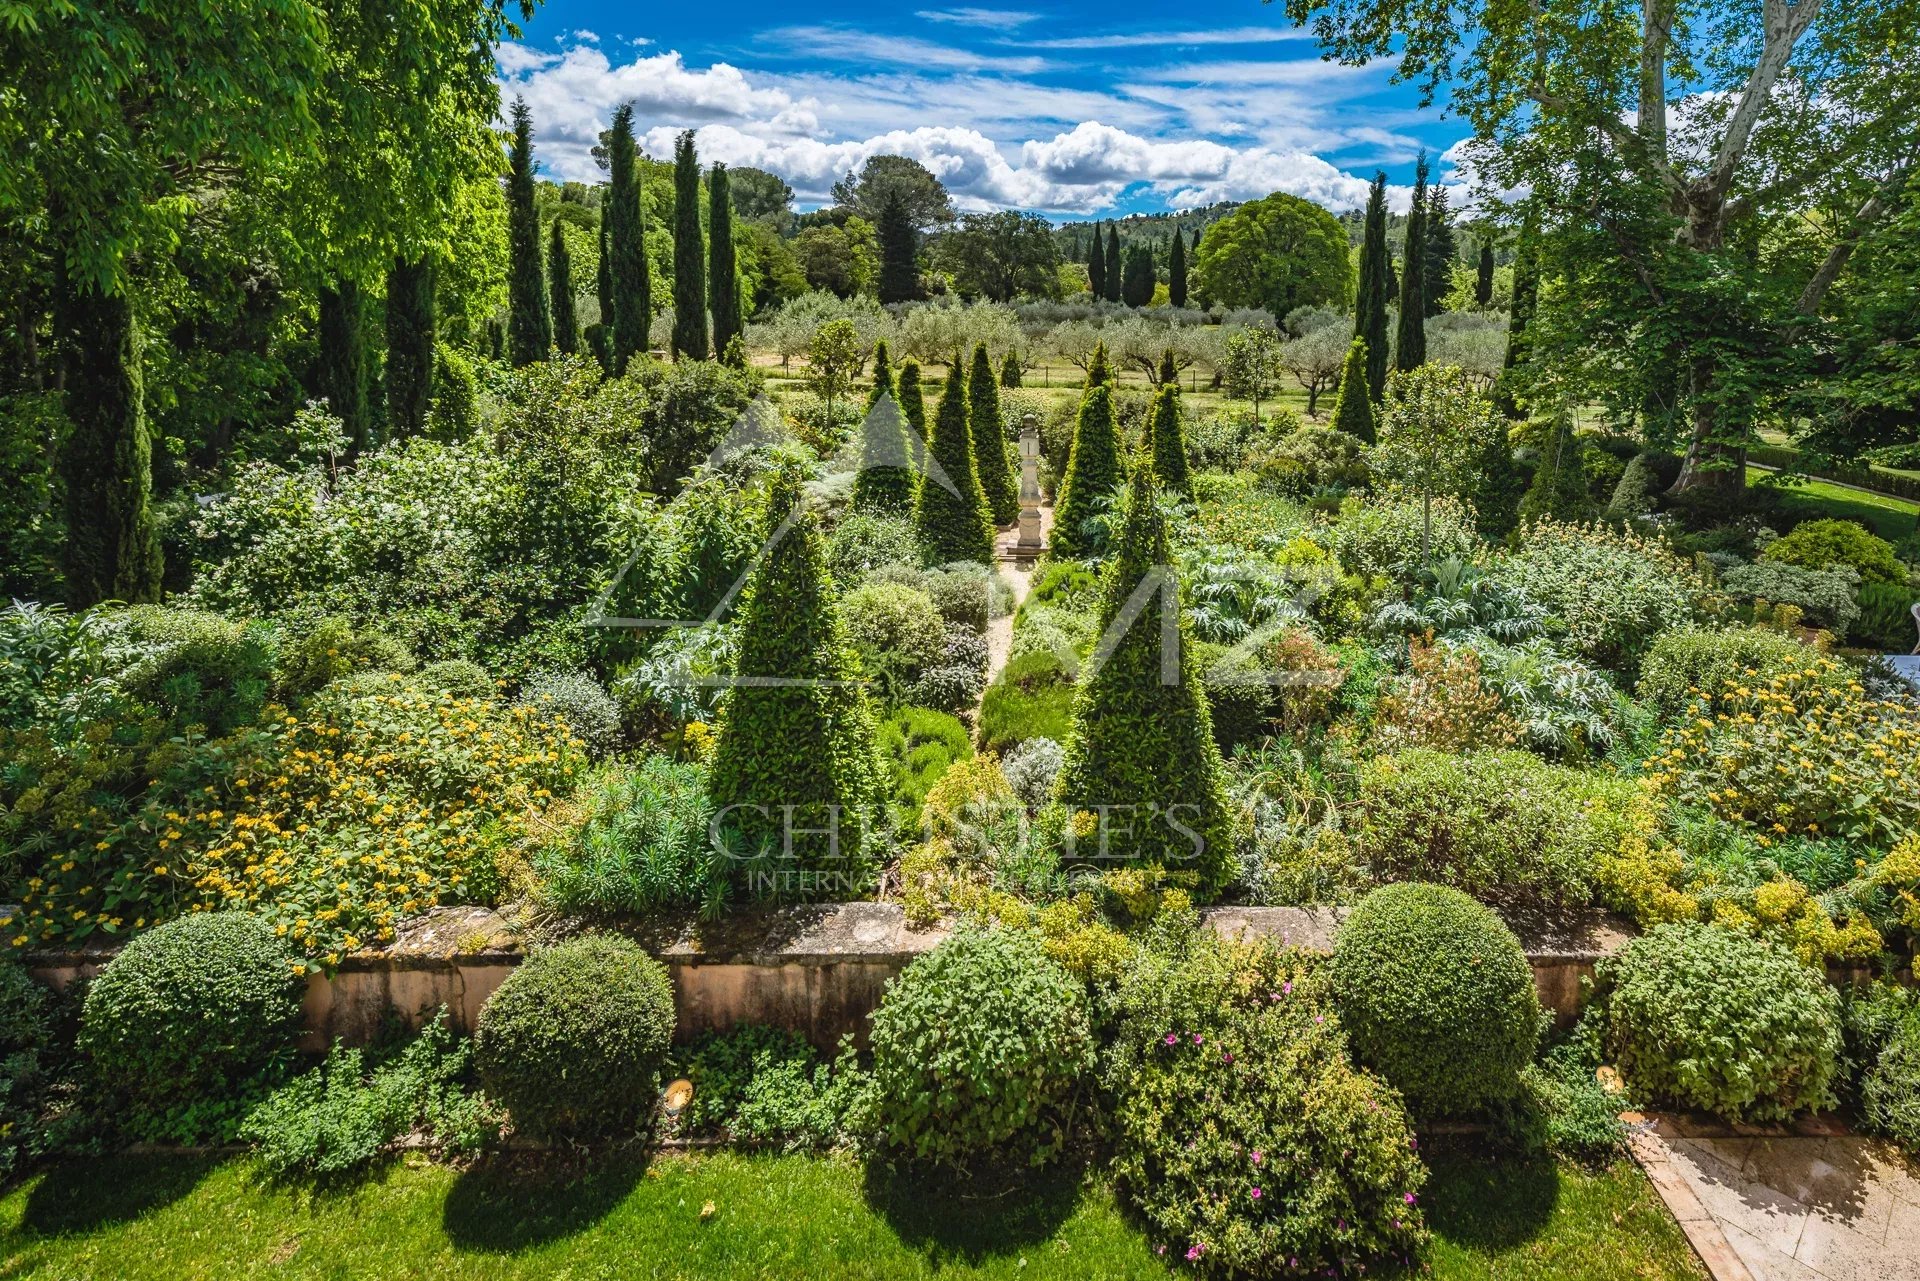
[474,933,674,1139]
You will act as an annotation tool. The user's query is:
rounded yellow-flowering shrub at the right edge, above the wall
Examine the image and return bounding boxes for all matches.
[1649,659,1920,849]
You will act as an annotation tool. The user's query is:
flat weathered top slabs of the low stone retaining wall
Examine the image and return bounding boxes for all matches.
[25,903,1634,972]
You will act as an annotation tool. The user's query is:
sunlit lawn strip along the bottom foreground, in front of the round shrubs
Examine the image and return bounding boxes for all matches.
[0,1148,1703,1281]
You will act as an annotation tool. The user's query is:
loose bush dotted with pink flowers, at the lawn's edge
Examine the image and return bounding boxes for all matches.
[1102,931,1427,1277]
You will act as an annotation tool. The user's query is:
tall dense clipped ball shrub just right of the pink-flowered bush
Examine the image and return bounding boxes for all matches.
[1329,883,1540,1116]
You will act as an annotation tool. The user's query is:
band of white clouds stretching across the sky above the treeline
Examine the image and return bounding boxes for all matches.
[497,37,1443,215]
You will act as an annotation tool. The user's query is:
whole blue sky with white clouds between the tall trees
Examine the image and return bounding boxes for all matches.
[499,0,1467,217]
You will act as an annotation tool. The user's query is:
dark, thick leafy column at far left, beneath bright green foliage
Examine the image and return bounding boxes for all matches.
[54,288,161,609]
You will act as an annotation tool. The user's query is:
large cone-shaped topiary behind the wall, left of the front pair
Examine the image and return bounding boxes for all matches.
[708,472,881,899]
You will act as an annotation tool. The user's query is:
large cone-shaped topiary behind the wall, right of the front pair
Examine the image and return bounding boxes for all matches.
[1054,467,1233,893]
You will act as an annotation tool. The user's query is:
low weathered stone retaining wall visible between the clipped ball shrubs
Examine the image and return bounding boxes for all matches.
[27,903,1630,1051]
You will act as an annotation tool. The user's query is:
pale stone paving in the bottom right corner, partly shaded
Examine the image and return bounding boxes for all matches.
[1626,1114,1920,1281]
